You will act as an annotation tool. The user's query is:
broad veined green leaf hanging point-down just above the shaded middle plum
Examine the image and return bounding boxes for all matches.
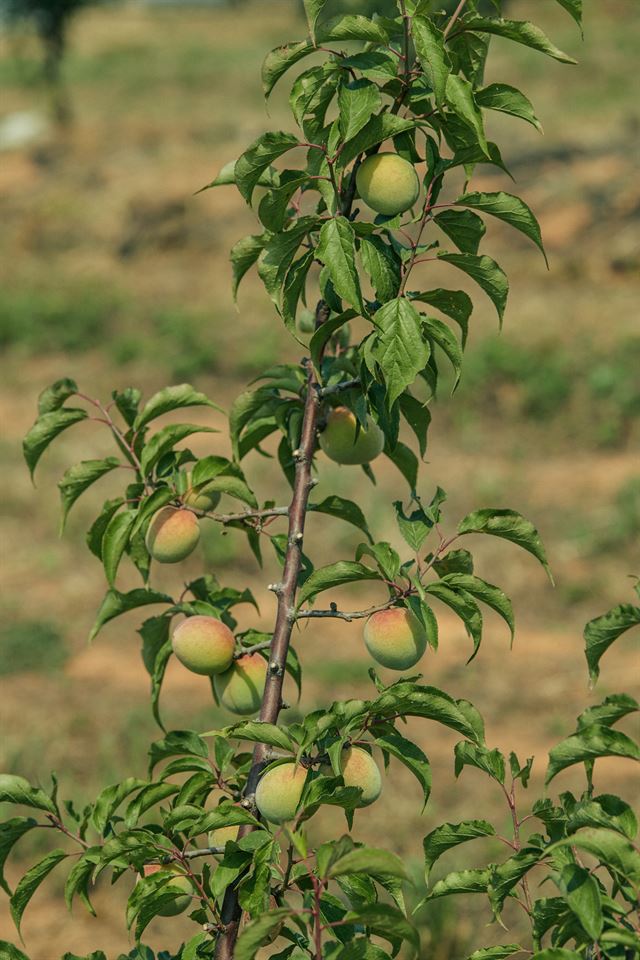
[372,297,430,407]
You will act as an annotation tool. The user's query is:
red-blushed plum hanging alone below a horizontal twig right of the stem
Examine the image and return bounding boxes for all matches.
[364,607,427,670]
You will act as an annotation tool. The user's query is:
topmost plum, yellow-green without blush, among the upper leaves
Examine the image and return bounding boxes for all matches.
[356,153,420,217]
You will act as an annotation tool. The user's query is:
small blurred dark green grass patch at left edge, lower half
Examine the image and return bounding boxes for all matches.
[0,620,67,676]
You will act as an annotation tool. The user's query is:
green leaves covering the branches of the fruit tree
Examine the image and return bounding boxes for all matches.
[5,0,640,960]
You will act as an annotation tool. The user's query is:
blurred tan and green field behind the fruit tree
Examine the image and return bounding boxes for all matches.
[0,0,640,960]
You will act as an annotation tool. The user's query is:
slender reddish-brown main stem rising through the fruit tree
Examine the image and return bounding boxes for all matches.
[215,314,328,960]
